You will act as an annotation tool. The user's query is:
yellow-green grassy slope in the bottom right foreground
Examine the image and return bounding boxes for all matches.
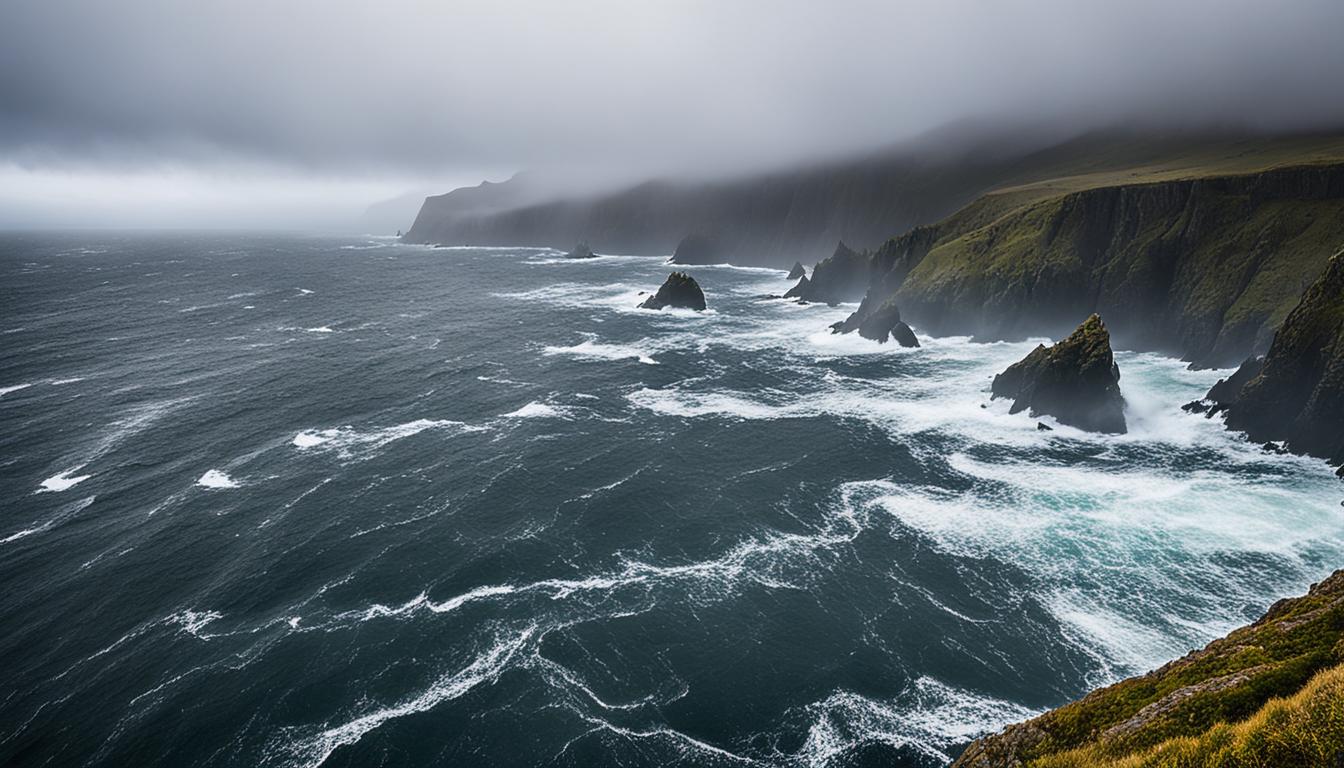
[953,570,1344,768]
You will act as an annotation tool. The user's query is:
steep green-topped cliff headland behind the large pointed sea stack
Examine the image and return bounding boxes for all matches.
[844,164,1344,367]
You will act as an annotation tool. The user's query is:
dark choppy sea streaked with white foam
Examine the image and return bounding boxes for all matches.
[0,234,1344,767]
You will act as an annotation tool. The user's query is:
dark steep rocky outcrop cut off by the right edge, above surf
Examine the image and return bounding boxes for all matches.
[1210,250,1344,463]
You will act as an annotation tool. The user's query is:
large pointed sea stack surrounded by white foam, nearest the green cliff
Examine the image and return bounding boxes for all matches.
[991,315,1126,433]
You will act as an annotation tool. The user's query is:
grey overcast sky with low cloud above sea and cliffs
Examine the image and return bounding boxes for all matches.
[0,0,1344,226]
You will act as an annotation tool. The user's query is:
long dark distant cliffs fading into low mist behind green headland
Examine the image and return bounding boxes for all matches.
[406,128,1268,268]
